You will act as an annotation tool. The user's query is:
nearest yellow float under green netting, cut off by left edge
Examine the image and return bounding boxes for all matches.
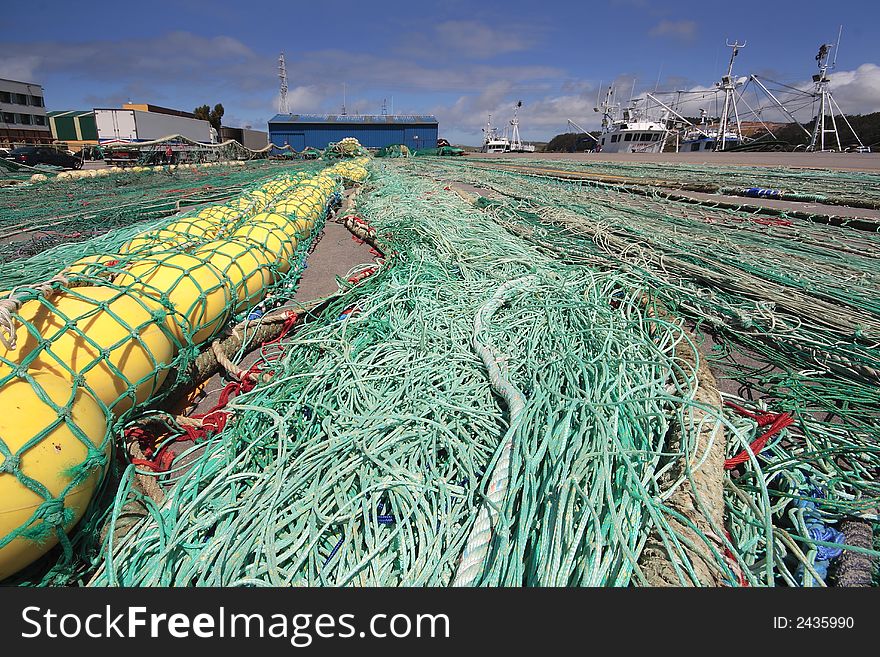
[0,372,112,581]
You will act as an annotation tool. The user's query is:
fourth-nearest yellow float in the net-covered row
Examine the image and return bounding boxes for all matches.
[193,238,275,313]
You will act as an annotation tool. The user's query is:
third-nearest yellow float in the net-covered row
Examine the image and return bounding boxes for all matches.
[114,253,232,344]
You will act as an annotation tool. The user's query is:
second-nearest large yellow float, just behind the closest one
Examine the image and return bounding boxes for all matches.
[0,286,176,415]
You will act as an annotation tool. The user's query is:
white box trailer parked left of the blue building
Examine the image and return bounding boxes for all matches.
[95,109,211,144]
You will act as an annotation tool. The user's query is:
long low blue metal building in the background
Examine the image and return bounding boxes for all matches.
[269,114,437,151]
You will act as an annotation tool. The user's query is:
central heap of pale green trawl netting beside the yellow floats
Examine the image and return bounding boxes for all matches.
[92,164,740,586]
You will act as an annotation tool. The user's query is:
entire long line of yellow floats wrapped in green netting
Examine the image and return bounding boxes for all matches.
[0,158,367,580]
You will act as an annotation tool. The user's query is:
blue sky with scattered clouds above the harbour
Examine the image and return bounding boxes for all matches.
[0,0,880,144]
